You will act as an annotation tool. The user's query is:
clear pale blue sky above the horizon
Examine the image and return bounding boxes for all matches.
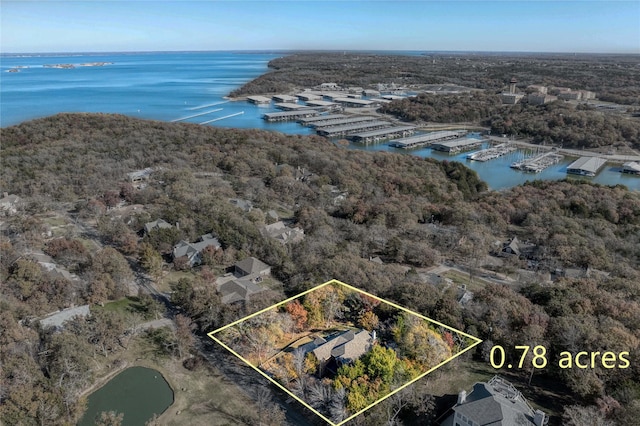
[0,0,640,53]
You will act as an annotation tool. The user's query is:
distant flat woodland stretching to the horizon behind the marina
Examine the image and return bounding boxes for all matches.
[231,52,640,106]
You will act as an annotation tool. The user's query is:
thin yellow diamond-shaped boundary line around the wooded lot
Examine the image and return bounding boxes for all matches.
[207,280,482,426]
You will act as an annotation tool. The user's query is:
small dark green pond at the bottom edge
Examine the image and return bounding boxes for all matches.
[78,367,173,426]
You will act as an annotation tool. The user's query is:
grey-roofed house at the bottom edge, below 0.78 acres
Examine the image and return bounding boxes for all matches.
[440,376,548,426]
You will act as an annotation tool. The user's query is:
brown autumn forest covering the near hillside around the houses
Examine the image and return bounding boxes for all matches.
[0,112,640,425]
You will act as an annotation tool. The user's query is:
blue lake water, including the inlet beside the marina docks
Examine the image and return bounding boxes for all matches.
[0,52,640,190]
